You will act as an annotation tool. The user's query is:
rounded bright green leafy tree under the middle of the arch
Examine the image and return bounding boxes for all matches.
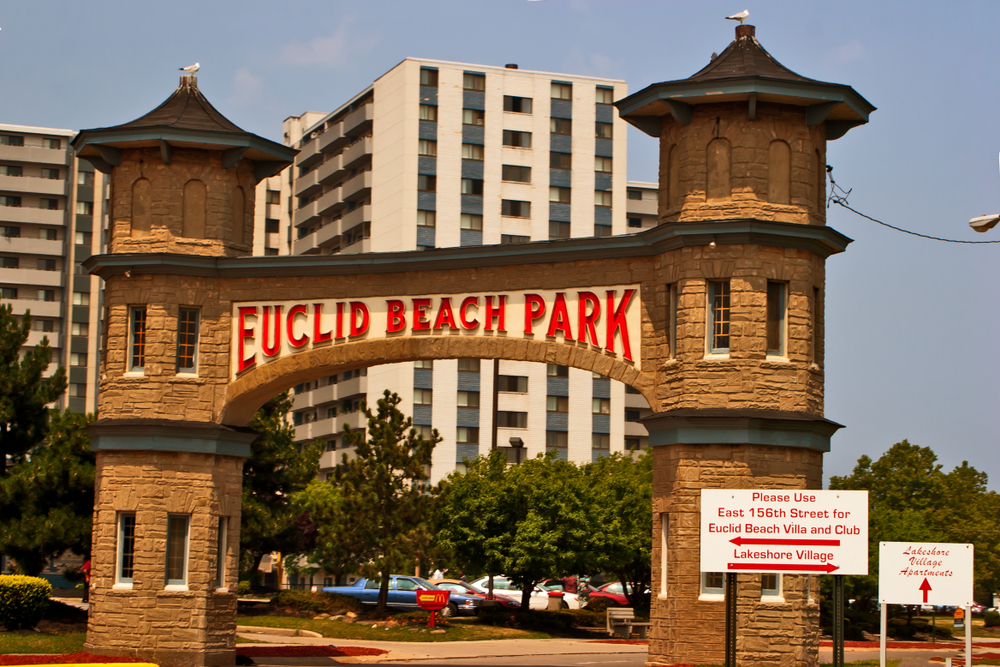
[439,452,594,610]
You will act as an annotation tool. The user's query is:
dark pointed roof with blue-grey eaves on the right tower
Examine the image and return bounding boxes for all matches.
[615,25,875,140]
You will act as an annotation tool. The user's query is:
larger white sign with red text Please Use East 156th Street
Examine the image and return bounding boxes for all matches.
[701,489,868,574]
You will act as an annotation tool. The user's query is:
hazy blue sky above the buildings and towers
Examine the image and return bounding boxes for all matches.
[0,0,1000,490]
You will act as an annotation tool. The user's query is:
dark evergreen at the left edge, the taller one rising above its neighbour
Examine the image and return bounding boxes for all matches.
[0,305,66,477]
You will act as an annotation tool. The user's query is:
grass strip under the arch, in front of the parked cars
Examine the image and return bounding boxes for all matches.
[237,614,552,642]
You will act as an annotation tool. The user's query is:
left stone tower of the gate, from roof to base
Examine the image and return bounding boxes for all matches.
[73,76,295,665]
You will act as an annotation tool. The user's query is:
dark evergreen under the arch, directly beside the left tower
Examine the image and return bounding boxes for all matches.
[240,392,323,576]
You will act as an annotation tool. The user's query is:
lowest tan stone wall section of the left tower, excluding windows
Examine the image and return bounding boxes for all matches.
[85,450,243,665]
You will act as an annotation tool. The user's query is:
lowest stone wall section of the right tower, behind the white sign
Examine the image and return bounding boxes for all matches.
[648,445,823,667]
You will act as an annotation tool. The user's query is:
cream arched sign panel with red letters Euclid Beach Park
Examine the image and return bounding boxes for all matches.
[232,285,641,377]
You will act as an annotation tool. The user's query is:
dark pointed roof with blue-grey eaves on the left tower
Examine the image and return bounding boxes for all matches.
[73,75,298,181]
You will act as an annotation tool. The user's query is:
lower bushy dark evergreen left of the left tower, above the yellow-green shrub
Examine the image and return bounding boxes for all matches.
[0,410,95,576]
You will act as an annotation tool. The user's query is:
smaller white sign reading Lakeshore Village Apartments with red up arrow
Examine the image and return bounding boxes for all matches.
[878,542,974,607]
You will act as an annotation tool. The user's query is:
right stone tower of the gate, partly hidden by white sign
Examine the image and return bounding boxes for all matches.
[616,25,874,667]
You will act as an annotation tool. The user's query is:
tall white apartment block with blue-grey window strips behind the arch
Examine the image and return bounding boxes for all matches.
[255,59,657,481]
